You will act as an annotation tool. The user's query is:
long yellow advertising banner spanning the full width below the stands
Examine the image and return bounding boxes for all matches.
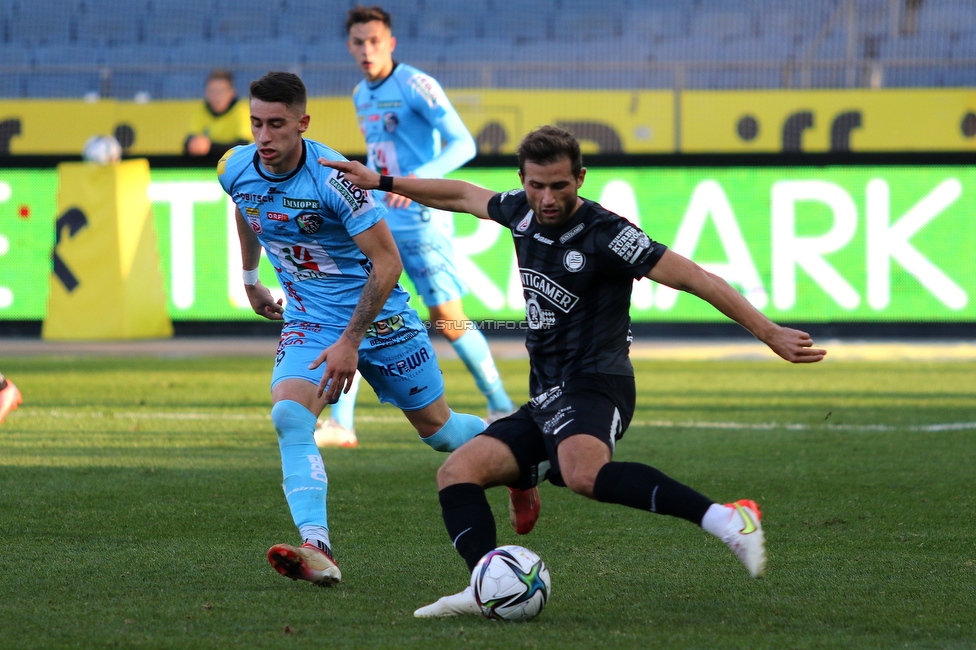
[0,88,976,156]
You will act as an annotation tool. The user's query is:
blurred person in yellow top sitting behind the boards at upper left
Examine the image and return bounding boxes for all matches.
[183,68,251,158]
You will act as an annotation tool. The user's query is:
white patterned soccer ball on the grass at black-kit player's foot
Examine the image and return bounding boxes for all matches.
[471,546,552,621]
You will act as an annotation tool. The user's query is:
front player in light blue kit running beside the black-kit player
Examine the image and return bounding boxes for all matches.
[217,72,485,586]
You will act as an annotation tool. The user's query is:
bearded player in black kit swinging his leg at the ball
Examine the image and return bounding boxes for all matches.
[320,126,826,618]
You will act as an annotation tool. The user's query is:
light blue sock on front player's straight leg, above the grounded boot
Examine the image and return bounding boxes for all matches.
[271,399,329,542]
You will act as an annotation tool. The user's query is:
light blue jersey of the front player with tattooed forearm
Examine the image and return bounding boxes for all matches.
[217,140,409,328]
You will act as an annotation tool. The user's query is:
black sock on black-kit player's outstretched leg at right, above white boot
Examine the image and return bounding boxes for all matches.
[593,462,713,526]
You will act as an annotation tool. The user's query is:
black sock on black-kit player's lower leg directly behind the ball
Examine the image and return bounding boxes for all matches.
[437,483,496,570]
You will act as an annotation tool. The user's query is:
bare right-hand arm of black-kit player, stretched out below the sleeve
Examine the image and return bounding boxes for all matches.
[647,250,827,363]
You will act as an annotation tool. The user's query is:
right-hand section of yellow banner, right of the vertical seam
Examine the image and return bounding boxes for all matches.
[680,88,976,153]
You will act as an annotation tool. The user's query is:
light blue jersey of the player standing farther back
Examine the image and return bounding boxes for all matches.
[352,63,476,233]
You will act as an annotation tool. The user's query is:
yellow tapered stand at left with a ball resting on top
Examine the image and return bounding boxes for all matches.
[41,159,173,340]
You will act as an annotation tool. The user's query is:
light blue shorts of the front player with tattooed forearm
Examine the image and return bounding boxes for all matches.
[271,309,444,411]
